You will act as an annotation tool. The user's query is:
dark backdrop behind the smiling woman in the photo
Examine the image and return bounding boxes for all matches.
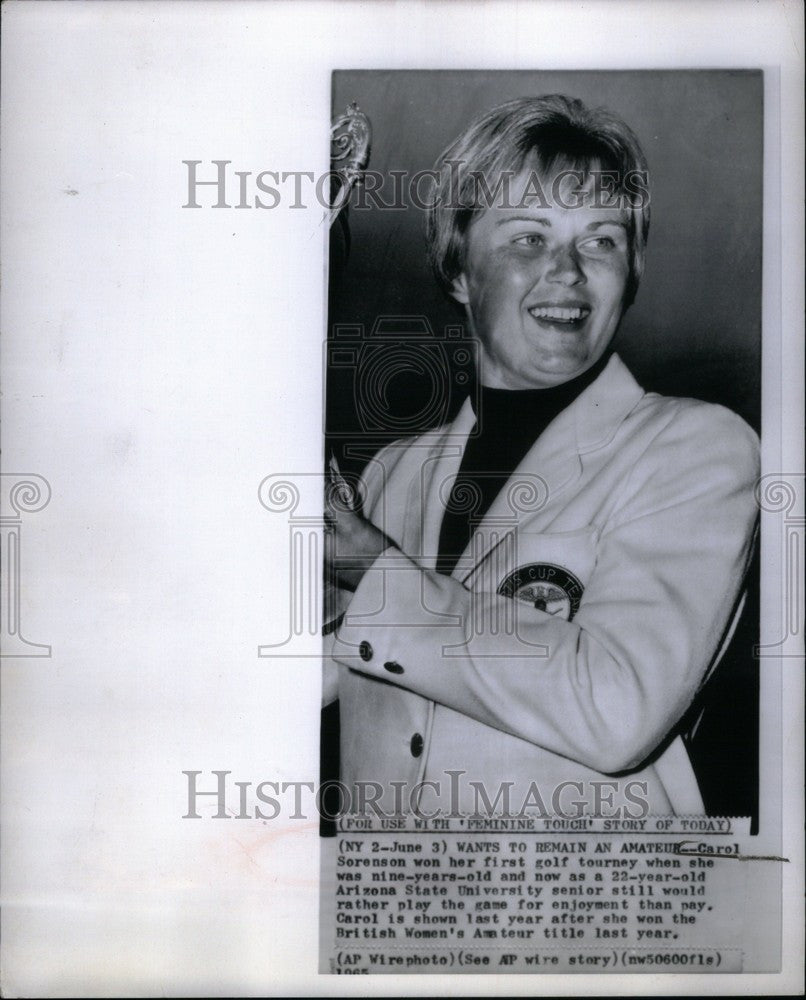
[323,70,763,828]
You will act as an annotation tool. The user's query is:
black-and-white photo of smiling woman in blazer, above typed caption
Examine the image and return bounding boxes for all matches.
[327,72,762,816]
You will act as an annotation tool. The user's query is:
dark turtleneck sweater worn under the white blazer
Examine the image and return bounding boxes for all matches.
[437,353,610,575]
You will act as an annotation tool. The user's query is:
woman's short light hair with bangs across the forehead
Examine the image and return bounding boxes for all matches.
[427,94,649,307]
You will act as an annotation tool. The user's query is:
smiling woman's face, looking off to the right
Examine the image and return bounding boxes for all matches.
[453,168,630,389]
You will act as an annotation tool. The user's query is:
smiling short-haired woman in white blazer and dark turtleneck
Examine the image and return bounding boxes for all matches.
[326,84,758,816]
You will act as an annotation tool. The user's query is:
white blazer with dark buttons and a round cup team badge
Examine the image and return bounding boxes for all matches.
[326,355,758,815]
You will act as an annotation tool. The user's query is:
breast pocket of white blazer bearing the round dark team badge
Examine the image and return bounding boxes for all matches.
[467,526,599,621]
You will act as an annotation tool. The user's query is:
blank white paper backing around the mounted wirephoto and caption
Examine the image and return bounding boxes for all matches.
[2,2,803,996]
